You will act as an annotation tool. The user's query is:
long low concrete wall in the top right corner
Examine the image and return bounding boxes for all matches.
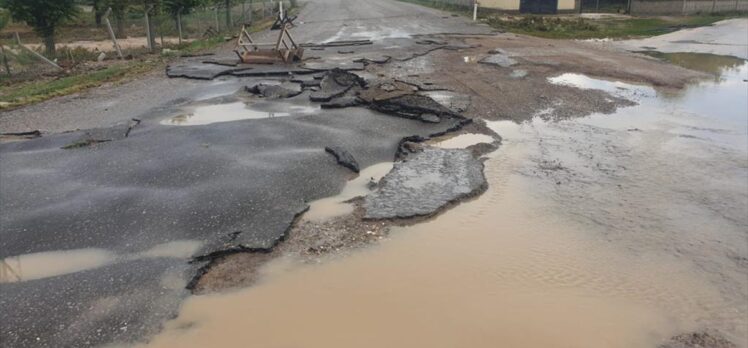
[631,0,748,15]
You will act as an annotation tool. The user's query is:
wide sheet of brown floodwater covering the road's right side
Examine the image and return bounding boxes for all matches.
[143,57,748,347]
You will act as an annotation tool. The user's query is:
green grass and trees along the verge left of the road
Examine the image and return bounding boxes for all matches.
[0,0,290,110]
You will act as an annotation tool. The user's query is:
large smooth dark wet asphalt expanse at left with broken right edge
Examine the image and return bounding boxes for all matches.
[0,93,468,346]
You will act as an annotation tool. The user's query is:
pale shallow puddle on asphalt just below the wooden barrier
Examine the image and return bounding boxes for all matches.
[161,101,320,126]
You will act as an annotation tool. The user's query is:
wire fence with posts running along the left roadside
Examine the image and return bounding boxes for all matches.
[0,0,292,80]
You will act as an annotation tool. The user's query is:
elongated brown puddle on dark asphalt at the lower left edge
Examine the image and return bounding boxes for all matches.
[0,240,201,283]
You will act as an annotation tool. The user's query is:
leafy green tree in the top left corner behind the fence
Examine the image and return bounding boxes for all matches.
[5,0,78,55]
